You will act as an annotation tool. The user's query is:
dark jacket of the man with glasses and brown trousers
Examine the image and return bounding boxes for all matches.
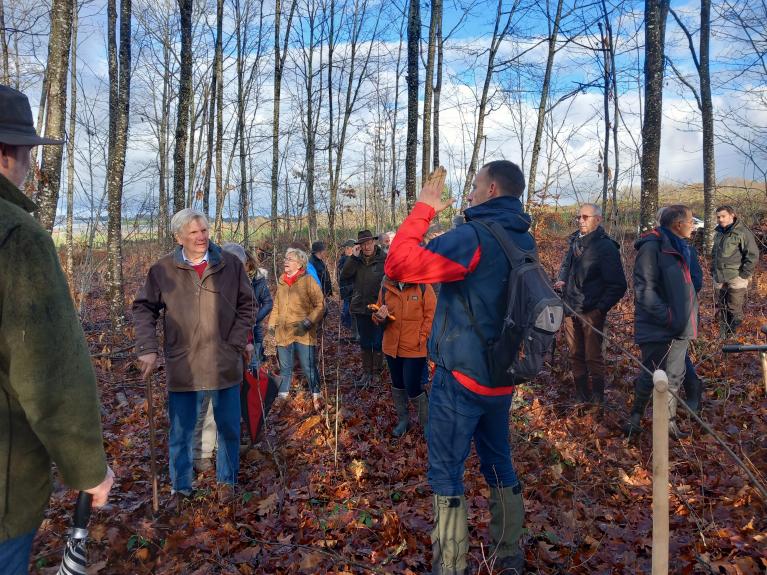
[557,226,626,314]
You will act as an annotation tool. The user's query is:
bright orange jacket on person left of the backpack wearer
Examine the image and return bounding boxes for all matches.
[378,278,437,357]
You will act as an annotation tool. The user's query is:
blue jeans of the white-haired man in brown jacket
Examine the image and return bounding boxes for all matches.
[168,385,240,493]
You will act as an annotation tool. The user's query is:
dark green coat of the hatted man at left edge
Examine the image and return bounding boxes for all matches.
[0,175,107,542]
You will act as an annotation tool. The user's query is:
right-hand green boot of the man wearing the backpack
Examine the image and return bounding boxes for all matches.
[490,484,525,575]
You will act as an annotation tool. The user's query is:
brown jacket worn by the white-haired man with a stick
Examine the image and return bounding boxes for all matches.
[133,242,256,391]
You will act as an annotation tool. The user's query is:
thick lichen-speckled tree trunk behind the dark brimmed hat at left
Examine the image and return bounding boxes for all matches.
[37,0,72,232]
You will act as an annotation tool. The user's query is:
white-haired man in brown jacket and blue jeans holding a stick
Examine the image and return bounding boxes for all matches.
[133,208,256,502]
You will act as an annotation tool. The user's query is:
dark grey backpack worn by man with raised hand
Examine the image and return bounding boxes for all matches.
[461,220,564,387]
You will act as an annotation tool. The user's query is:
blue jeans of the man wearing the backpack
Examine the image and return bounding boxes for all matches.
[427,367,519,497]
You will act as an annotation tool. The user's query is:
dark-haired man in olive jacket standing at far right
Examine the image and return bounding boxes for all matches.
[711,206,759,337]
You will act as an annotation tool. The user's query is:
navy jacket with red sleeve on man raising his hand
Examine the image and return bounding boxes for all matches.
[386,196,535,396]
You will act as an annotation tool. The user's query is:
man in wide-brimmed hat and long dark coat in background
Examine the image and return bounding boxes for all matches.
[341,230,386,387]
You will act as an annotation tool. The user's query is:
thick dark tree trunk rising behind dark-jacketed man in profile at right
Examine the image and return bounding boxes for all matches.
[640,0,669,231]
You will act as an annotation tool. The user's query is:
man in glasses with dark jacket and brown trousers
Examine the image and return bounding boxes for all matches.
[554,204,626,404]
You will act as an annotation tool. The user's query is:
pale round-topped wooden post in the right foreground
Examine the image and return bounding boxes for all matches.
[652,370,669,575]
